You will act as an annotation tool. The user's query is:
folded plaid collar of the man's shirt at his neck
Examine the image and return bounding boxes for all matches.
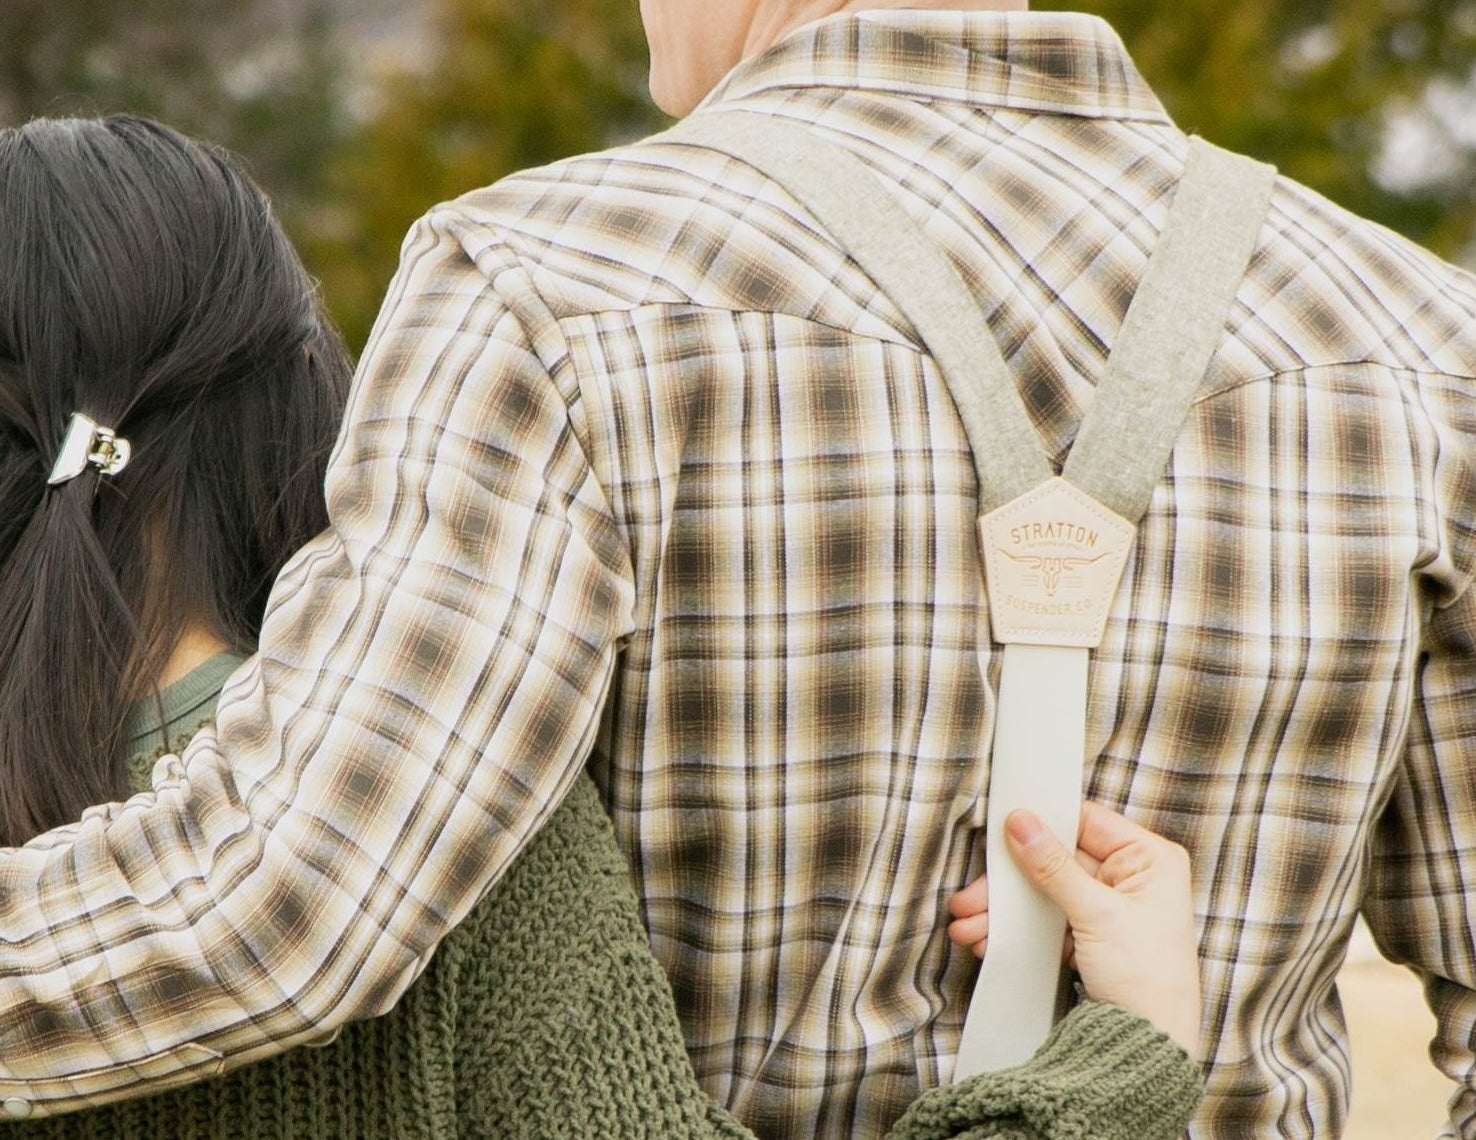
[703,9,1169,124]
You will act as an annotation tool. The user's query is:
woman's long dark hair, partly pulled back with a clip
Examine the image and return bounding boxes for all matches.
[0,117,350,845]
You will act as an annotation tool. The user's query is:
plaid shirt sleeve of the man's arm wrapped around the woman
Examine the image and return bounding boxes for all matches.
[0,207,633,1116]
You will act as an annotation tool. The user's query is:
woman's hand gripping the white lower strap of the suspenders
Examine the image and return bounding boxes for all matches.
[948,803,1200,1057]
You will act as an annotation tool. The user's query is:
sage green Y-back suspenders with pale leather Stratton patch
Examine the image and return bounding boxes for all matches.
[658,111,1275,1081]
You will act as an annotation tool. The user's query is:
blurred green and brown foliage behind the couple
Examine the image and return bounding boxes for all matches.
[0,0,1476,348]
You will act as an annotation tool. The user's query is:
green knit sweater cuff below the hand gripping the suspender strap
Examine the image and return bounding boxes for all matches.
[892,1001,1203,1140]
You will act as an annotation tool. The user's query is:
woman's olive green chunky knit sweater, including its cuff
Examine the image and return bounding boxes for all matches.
[11,656,1199,1140]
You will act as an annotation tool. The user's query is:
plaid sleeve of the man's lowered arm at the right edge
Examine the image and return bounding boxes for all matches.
[1364,437,1476,1137]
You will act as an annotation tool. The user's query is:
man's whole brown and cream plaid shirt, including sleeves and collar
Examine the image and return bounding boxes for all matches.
[0,12,1476,1137]
